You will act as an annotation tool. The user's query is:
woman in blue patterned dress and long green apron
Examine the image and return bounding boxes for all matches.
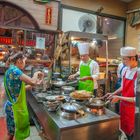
[4,52,43,140]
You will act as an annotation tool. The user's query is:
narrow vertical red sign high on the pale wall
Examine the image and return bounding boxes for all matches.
[46,6,52,25]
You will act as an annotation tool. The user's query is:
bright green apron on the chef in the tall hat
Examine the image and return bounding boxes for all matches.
[78,60,94,93]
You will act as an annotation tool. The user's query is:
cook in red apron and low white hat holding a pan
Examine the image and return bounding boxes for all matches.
[106,47,138,140]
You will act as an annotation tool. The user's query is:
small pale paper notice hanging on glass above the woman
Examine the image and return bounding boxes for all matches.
[36,37,45,49]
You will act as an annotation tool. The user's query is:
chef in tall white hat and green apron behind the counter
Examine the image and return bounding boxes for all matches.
[69,43,99,96]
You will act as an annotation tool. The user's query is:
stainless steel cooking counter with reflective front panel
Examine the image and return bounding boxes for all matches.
[27,91,119,140]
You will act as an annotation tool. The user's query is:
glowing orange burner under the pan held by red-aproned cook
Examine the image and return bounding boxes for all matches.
[87,108,105,116]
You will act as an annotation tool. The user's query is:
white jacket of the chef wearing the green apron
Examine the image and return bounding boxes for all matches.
[77,59,99,89]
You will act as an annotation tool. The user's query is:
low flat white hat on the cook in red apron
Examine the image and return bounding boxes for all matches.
[120,46,137,56]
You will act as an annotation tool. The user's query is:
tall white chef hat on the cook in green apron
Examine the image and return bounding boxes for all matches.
[78,43,89,55]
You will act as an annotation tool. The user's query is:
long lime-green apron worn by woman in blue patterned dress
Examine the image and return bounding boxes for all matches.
[4,76,30,140]
